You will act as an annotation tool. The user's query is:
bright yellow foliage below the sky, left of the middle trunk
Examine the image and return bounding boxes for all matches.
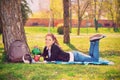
[30,0,63,19]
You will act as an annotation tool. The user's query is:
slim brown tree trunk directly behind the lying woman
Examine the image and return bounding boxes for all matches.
[63,0,70,43]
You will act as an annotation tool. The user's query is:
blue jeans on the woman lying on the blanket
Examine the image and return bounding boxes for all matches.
[72,40,99,62]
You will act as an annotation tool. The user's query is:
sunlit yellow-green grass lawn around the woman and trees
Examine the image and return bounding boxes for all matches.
[0,27,120,80]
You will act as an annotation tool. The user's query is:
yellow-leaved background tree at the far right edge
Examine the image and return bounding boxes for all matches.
[102,0,120,31]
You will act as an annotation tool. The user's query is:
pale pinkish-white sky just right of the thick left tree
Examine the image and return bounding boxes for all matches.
[27,0,50,12]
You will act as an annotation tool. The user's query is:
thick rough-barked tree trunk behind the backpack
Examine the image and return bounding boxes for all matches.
[0,0,29,53]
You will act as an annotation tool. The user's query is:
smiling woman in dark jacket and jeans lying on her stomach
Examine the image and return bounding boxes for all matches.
[41,33,105,62]
